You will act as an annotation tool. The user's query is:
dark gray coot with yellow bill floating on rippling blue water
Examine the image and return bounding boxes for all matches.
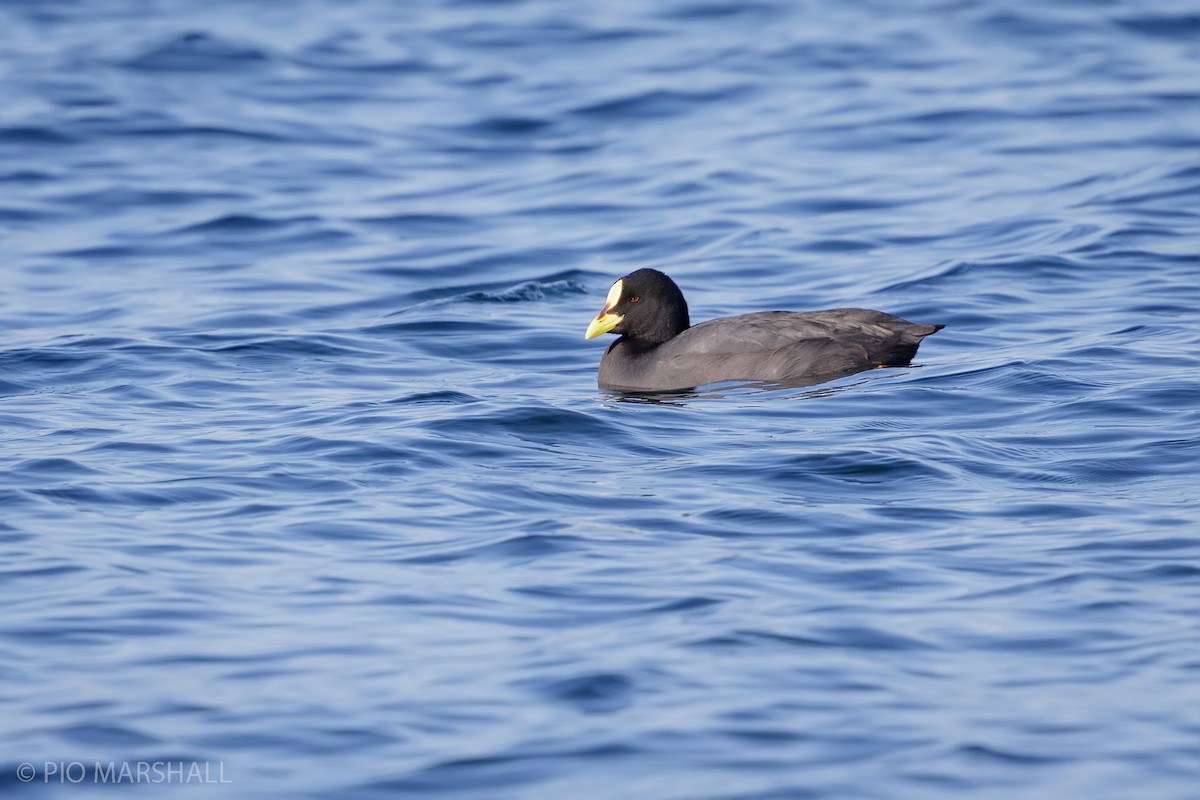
[587,270,943,391]
